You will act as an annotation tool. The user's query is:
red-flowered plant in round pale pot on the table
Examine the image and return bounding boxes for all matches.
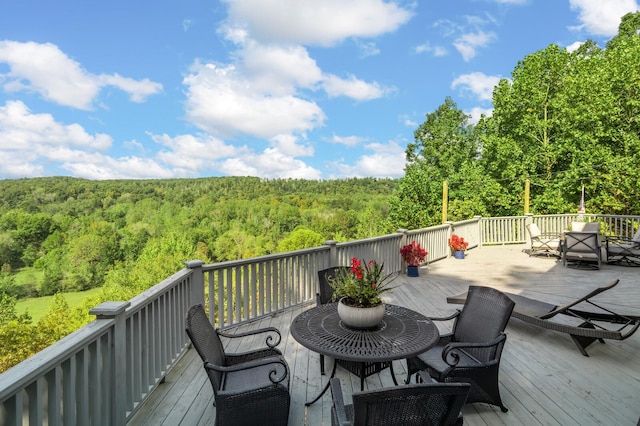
[329,257,393,329]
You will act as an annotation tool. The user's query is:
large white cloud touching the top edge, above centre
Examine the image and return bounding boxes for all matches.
[223,0,413,46]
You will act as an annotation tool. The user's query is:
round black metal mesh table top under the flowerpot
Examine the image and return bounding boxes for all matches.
[291,303,439,362]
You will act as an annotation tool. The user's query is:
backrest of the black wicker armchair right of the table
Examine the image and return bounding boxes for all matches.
[453,286,515,356]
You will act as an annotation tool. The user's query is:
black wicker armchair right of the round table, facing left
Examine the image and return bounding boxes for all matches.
[406,286,515,412]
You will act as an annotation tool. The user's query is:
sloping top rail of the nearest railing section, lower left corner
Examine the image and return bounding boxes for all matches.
[0,320,112,401]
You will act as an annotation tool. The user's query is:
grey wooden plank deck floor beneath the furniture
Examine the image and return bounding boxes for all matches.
[129,246,640,426]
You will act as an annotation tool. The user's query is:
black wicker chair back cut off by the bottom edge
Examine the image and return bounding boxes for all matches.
[331,373,470,426]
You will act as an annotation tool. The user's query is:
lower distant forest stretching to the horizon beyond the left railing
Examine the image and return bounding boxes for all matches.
[0,177,398,371]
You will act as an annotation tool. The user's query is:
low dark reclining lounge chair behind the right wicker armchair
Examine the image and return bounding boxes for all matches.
[447,280,640,356]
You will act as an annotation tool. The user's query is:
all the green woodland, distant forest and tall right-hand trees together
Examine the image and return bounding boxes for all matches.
[0,12,640,371]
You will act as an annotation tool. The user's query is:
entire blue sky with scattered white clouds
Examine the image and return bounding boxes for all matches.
[0,0,639,180]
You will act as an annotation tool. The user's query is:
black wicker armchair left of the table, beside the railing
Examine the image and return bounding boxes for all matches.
[186,305,291,426]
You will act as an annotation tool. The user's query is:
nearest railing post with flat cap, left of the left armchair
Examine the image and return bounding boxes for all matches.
[89,302,131,426]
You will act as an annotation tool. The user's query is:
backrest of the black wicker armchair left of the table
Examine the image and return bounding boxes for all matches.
[186,305,226,392]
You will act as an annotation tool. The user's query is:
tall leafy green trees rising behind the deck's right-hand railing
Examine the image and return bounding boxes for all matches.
[390,12,640,228]
